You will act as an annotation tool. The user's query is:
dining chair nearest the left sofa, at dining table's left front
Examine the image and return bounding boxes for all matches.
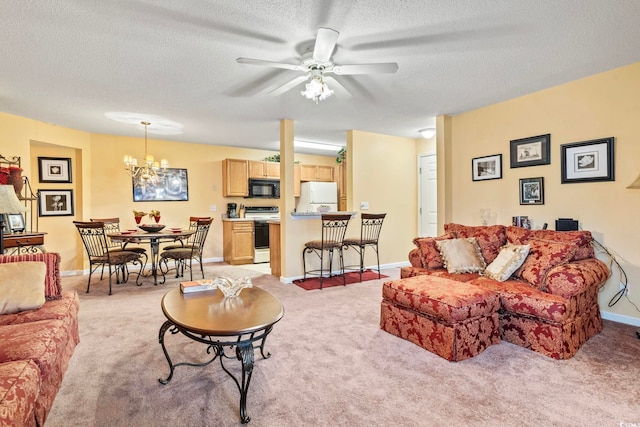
[73,221,142,295]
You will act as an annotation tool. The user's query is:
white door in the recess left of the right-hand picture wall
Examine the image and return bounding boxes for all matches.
[418,154,438,237]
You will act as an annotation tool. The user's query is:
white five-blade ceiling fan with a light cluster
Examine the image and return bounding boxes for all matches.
[236,28,398,104]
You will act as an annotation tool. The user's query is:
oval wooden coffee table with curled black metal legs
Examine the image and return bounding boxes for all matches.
[158,287,284,424]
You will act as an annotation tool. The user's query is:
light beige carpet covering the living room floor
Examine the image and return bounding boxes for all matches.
[46,264,640,427]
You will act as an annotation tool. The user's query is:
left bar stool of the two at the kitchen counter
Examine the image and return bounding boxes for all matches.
[302,214,351,289]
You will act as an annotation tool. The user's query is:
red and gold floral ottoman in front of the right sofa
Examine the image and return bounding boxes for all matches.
[380,275,500,361]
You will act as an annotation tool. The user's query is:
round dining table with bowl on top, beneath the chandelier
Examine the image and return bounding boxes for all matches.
[107,228,196,285]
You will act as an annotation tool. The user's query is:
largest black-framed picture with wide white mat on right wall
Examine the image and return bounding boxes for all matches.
[560,137,615,184]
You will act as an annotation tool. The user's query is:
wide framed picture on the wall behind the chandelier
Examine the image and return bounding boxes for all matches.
[132,168,189,202]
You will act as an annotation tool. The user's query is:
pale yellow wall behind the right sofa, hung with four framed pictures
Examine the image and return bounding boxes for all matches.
[446,63,640,324]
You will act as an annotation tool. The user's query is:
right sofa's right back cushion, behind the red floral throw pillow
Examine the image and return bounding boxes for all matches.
[506,226,594,260]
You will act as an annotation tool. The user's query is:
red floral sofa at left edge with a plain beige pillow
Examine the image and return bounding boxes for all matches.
[0,253,80,426]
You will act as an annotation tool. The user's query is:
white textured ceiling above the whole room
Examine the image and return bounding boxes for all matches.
[0,0,640,155]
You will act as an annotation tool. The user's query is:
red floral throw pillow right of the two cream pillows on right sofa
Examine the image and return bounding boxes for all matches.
[515,239,576,291]
